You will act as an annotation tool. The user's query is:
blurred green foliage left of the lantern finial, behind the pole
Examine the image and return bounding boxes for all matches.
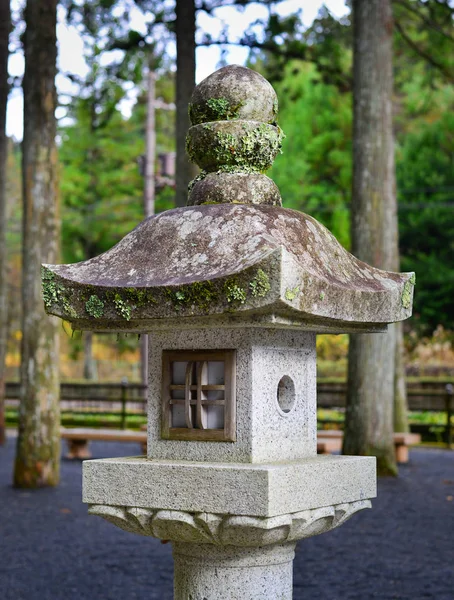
[59,67,174,262]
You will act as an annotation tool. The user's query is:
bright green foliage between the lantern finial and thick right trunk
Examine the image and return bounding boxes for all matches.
[269,61,352,247]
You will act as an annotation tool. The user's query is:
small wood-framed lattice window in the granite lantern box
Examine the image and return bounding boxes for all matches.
[161,350,236,442]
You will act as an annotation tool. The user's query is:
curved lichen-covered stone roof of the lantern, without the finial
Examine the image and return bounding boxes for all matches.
[43,204,414,331]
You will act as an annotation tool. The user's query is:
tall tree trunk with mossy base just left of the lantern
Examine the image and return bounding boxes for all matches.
[14,0,60,487]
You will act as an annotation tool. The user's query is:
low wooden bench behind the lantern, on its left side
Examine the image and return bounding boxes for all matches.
[60,427,147,459]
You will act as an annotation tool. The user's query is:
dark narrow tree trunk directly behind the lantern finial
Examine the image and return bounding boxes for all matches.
[175,0,197,206]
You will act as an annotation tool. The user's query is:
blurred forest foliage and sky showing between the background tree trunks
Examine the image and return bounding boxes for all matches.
[6,0,454,381]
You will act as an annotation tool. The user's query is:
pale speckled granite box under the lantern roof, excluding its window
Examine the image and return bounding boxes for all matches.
[148,328,317,463]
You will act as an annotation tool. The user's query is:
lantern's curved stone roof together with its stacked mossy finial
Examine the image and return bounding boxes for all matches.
[43,65,414,332]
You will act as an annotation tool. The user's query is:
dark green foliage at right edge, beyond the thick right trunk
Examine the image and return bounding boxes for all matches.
[397,90,454,329]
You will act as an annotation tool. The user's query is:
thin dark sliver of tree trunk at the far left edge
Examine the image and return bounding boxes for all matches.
[0,0,11,446]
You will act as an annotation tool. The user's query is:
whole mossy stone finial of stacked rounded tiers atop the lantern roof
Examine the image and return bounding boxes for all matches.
[186,65,283,206]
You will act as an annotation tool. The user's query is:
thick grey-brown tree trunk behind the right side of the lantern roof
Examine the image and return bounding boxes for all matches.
[343,0,399,475]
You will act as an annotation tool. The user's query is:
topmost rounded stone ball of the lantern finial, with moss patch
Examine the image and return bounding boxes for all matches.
[189,65,278,125]
